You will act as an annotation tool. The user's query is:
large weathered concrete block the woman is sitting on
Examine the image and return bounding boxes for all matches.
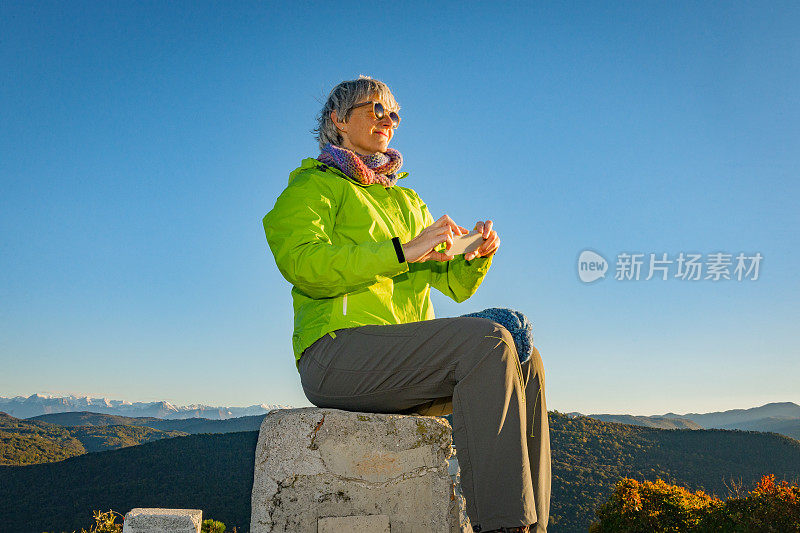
[250,407,472,533]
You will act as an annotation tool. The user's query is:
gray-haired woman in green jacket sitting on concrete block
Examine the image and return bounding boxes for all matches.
[264,76,550,533]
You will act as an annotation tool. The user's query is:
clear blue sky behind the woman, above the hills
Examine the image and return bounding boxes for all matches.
[0,0,800,414]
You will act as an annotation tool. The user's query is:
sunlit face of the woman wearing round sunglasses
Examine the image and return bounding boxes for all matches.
[331,96,394,155]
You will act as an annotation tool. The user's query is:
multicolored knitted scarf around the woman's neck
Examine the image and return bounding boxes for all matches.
[317,143,403,187]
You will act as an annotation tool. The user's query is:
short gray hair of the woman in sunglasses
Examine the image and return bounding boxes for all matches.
[312,75,400,150]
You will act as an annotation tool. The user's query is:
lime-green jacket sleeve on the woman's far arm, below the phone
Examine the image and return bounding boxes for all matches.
[414,196,494,303]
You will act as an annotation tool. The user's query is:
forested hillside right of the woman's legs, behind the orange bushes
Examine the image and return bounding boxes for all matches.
[548,412,800,531]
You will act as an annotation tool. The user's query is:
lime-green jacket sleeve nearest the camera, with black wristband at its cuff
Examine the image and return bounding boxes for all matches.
[263,174,409,298]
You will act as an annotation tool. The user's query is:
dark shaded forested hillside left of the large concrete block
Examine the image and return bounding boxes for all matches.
[0,431,258,533]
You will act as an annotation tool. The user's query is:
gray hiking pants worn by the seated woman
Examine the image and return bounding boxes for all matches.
[299,317,550,533]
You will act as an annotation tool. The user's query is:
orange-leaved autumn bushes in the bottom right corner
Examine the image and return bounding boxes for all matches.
[589,475,800,533]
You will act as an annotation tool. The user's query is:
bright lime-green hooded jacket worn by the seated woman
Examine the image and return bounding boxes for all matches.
[264,158,492,365]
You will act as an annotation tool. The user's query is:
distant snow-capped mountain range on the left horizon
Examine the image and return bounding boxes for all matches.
[0,394,289,420]
